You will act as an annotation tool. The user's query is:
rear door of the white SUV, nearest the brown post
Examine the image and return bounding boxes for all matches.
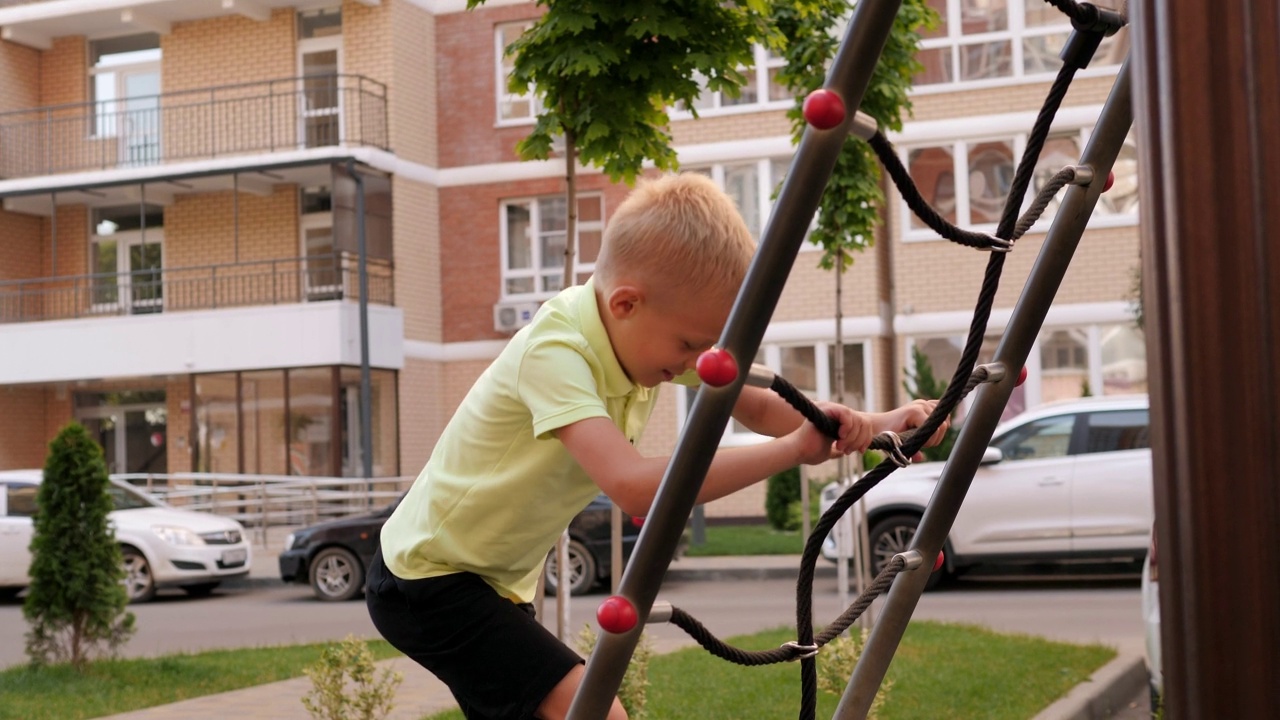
[1071,409,1153,555]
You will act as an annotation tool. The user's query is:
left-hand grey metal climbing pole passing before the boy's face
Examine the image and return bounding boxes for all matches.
[568,0,901,720]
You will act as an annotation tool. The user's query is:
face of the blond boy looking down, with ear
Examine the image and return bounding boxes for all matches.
[607,281,733,387]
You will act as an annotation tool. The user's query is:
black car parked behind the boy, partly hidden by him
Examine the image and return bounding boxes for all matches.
[280,495,665,601]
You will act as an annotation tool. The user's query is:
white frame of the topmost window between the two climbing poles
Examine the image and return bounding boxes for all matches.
[911,0,1124,95]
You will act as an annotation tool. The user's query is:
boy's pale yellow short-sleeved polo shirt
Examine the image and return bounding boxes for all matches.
[381,281,658,602]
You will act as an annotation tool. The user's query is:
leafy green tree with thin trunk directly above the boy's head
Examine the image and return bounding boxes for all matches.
[467,0,772,286]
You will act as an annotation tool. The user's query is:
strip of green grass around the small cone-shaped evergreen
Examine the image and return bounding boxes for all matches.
[0,641,399,720]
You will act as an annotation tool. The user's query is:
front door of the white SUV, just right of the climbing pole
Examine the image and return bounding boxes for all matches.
[950,414,1076,559]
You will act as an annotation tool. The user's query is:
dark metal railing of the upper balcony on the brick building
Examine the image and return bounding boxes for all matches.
[0,74,388,178]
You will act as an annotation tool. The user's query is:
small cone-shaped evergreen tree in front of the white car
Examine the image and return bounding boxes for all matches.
[22,423,134,670]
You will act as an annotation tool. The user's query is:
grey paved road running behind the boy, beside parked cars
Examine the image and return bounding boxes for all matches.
[0,568,1142,667]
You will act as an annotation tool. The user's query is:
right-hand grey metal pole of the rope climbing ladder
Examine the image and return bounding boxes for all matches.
[836,61,1133,720]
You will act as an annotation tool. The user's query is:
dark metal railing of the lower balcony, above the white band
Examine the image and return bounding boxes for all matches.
[0,252,396,323]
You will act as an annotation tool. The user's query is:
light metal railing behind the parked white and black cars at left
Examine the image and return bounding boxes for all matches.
[111,473,413,546]
